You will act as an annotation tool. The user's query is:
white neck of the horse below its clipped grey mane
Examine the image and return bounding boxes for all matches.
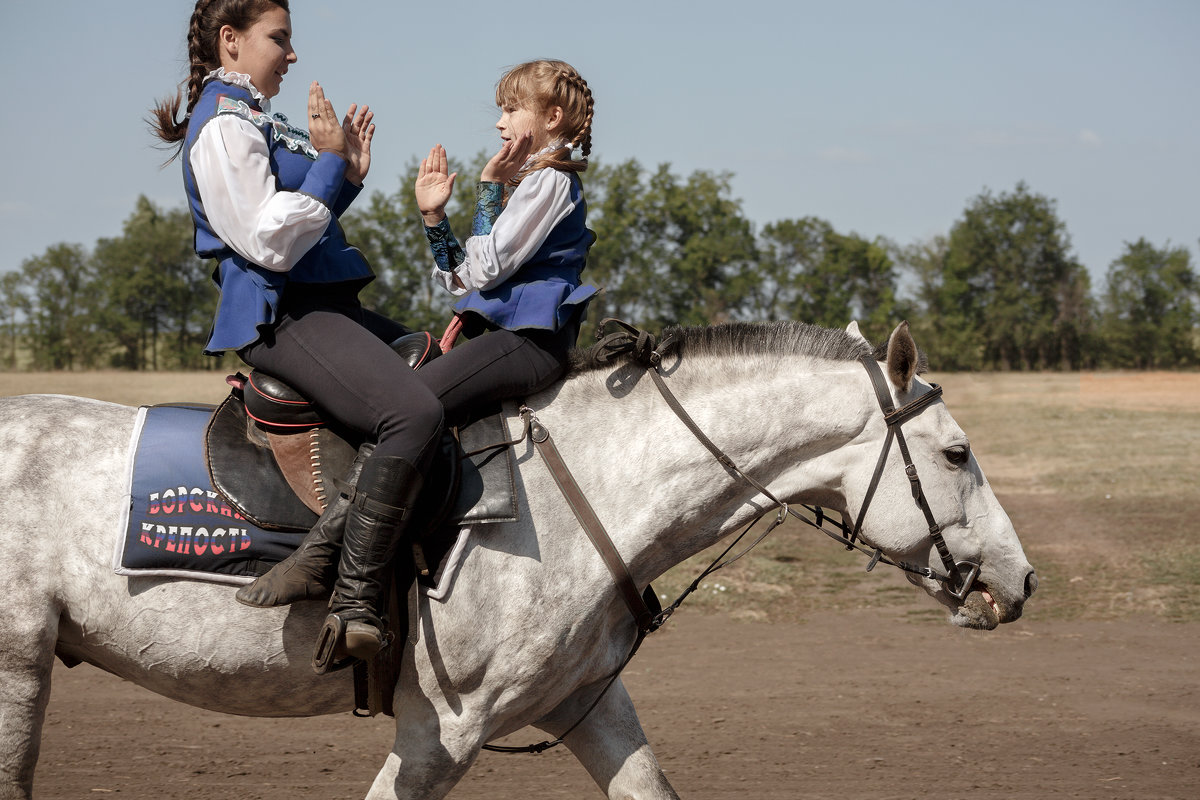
[530,356,866,582]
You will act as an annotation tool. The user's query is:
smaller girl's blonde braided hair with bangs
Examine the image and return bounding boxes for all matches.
[496,59,595,186]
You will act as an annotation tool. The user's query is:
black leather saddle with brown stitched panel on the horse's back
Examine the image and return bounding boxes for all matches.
[204,332,517,542]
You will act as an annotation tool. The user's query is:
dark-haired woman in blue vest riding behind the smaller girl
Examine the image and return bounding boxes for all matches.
[154,0,443,673]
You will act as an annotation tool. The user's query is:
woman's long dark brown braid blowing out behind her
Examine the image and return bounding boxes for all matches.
[146,0,290,163]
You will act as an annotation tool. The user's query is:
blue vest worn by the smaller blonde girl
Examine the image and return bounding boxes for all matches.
[454,174,598,336]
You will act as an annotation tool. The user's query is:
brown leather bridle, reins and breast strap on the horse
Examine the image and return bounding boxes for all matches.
[484,318,979,753]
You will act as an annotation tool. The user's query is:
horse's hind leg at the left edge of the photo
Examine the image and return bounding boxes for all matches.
[0,602,58,800]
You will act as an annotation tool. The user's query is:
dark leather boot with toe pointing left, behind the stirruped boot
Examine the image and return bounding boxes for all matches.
[234,443,374,608]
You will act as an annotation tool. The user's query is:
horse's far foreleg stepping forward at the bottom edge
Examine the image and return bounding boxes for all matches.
[538,680,679,800]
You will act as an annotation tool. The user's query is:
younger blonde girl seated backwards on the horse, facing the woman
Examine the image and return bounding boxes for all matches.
[415,60,596,425]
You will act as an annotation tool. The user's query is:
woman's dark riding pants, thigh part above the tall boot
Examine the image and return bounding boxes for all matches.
[238,287,443,473]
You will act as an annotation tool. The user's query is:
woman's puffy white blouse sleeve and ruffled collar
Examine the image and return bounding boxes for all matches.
[188,70,332,272]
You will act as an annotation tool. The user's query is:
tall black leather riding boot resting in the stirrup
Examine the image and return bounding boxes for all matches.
[312,456,424,675]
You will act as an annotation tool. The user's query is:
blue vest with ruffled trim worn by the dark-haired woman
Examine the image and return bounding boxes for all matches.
[184,79,374,355]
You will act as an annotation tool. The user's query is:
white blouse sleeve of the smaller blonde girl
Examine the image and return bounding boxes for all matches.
[432,167,576,296]
